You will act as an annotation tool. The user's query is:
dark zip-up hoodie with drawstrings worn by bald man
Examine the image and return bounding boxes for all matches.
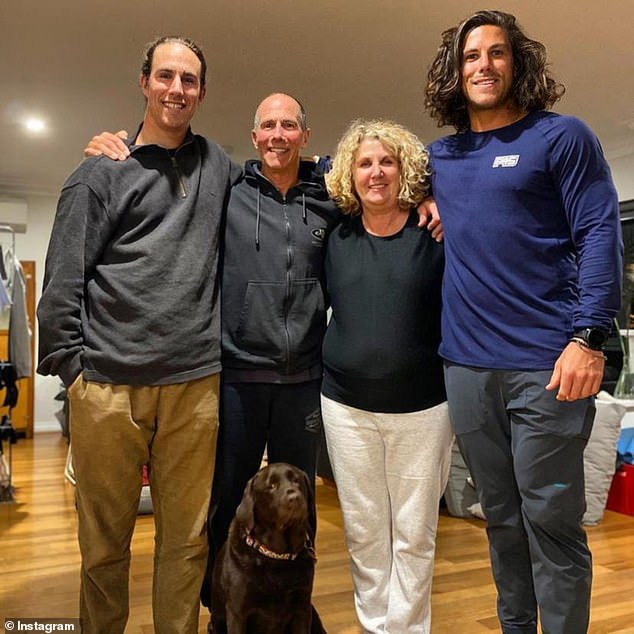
[221,161,340,383]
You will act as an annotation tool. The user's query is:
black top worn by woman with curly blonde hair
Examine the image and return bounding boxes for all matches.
[322,212,446,413]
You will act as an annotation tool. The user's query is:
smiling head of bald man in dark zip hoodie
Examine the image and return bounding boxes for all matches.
[251,94,310,178]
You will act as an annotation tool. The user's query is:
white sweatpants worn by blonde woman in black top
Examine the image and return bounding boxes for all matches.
[321,395,453,634]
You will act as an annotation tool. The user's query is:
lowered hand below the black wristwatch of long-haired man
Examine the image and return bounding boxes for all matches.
[546,342,605,401]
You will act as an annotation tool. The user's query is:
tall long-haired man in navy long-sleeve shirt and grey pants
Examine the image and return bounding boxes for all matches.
[426,11,622,634]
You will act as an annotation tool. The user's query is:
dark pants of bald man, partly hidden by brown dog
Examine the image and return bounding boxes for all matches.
[201,379,321,607]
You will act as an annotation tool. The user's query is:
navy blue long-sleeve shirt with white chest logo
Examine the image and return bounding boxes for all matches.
[429,111,622,370]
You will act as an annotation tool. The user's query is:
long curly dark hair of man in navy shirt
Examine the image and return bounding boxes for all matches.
[425,11,565,132]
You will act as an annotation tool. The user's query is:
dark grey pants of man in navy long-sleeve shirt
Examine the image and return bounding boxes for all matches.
[445,363,594,634]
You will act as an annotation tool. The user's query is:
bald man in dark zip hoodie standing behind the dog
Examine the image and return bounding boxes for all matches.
[211,93,339,548]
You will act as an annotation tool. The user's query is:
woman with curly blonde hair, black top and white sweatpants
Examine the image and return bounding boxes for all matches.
[322,121,453,634]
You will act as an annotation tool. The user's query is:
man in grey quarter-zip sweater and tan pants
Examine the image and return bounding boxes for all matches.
[38,38,239,634]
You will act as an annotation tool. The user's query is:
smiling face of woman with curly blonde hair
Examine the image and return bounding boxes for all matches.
[352,138,400,212]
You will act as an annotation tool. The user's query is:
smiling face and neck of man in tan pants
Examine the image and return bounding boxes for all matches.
[140,42,205,147]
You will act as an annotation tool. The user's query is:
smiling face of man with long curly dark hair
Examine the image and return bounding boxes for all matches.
[462,25,517,128]
